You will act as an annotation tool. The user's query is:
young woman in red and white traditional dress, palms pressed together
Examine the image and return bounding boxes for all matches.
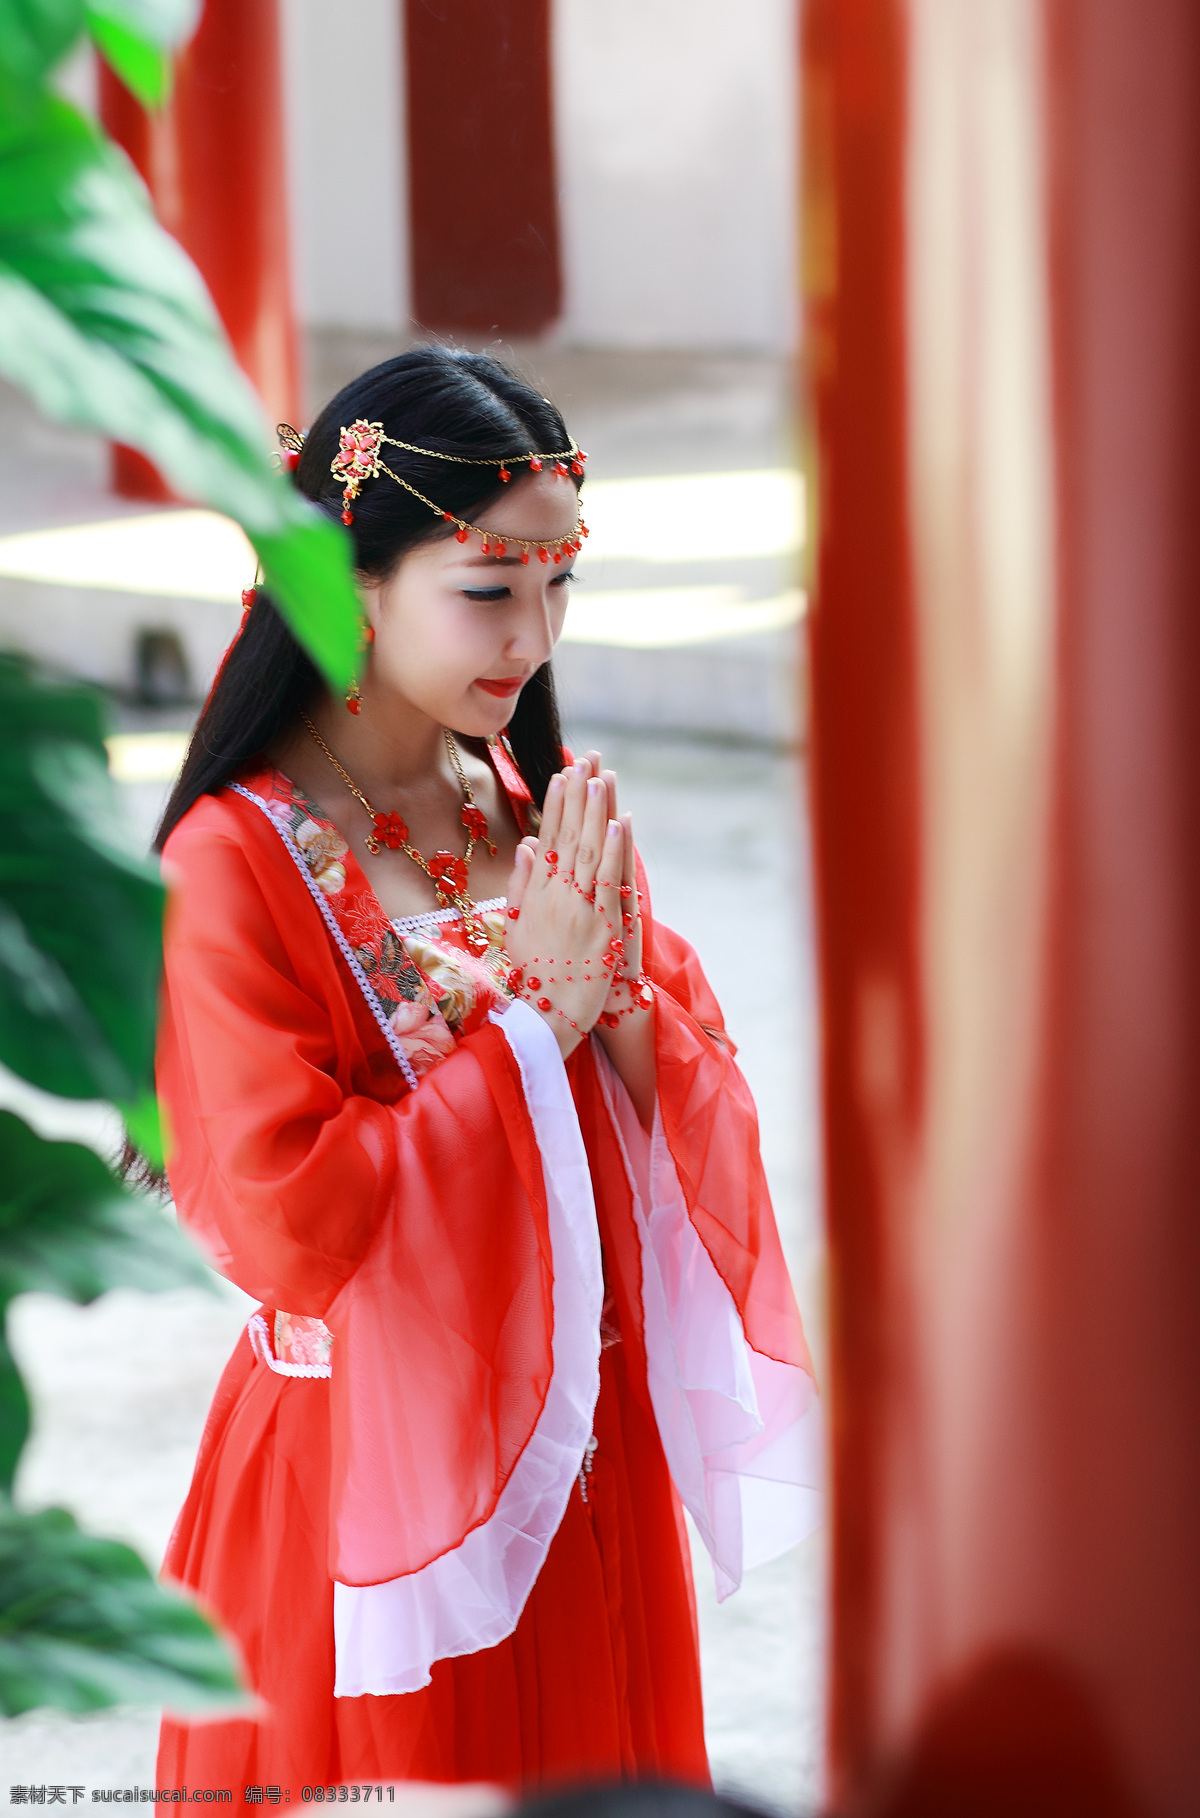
[158,347,818,1800]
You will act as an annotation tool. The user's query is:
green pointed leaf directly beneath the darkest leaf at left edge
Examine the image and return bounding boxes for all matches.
[0,1111,213,1305]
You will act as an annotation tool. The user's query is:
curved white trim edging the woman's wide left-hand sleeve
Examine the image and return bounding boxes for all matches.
[333,1000,604,1698]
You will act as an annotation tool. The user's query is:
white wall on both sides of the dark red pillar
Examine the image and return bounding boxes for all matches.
[272,0,798,351]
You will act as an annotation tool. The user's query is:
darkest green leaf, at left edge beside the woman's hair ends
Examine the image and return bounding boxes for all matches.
[0,656,165,1104]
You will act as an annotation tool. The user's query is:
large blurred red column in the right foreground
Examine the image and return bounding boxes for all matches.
[804,0,1200,1818]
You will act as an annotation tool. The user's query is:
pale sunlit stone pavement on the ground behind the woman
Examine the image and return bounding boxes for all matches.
[0,711,824,1814]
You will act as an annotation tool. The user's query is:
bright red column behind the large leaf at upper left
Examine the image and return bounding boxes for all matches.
[100,0,300,498]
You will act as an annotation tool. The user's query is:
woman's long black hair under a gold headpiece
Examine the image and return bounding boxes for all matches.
[155,347,571,851]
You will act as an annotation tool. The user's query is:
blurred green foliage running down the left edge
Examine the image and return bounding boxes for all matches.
[0,0,358,1714]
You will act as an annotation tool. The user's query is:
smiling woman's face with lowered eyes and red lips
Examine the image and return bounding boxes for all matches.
[364,473,576,738]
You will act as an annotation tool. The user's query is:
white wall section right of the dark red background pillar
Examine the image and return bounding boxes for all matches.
[555,0,798,349]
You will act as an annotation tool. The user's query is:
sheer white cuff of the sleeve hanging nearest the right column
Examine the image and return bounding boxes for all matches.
[593,1044,825,1600]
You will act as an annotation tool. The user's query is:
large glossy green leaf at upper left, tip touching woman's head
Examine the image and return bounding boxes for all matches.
[0,94,358,689]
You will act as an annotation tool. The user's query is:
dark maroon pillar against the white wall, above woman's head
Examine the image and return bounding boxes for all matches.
[405,0,562,335]
